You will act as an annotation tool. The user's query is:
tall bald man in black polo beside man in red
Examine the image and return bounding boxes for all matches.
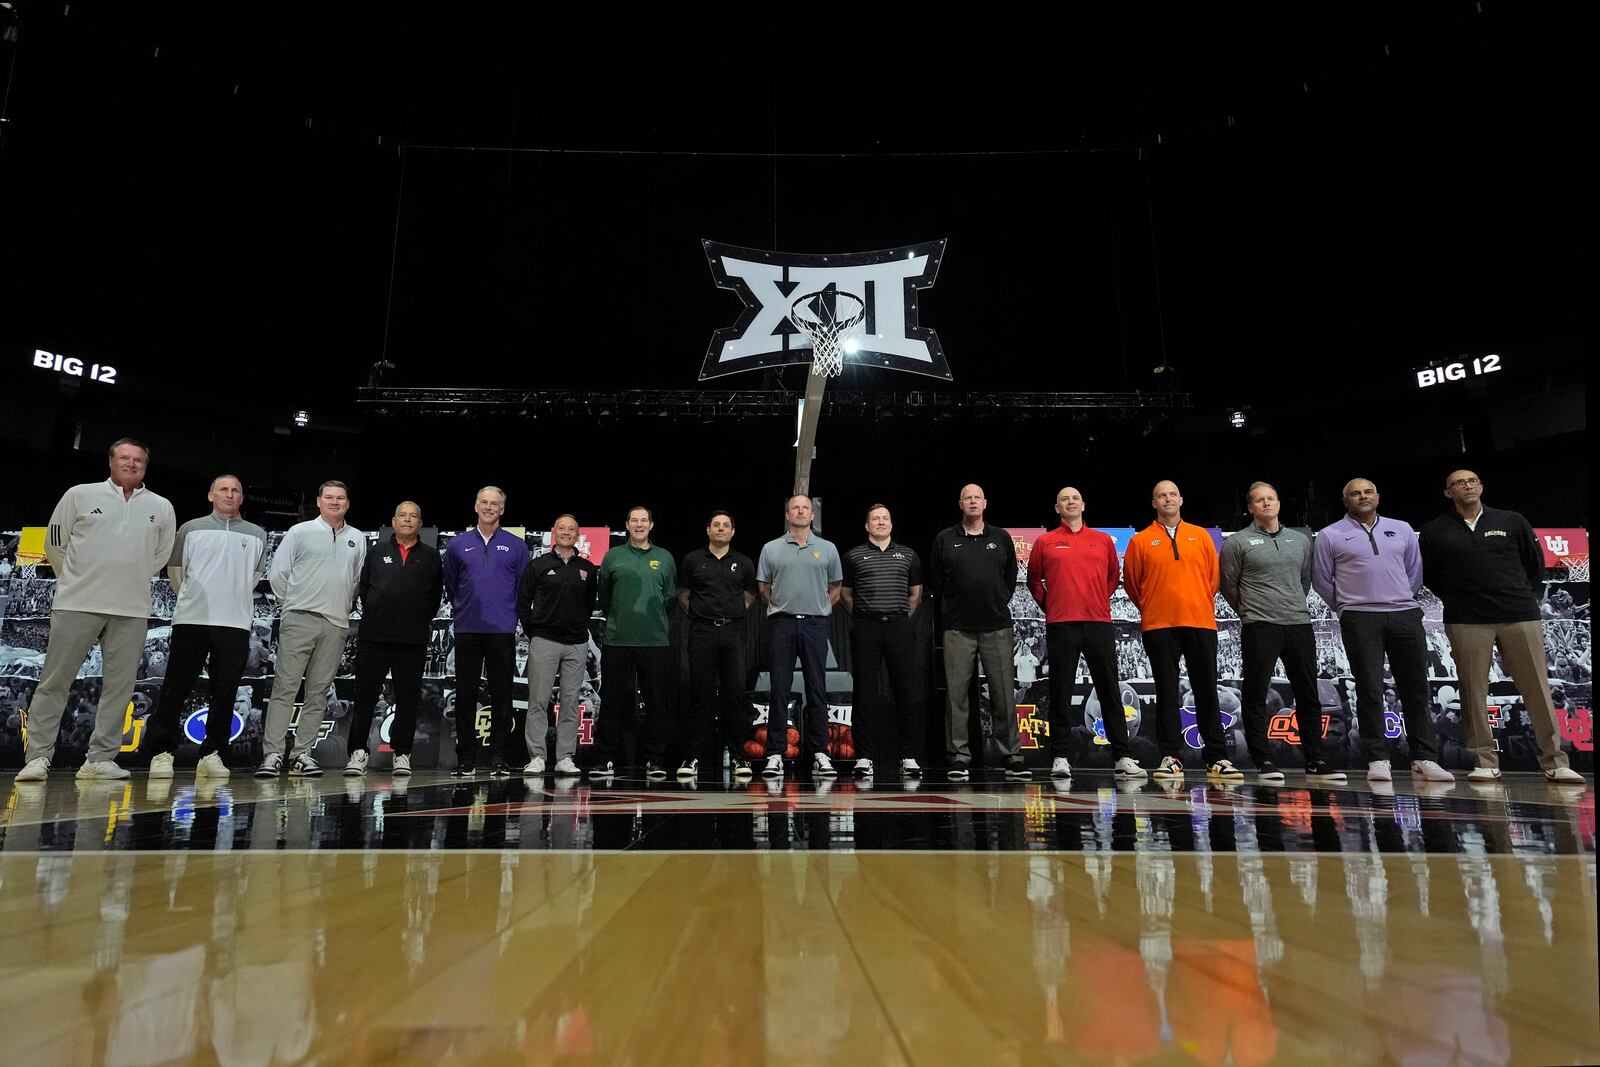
[926,485,1034,782]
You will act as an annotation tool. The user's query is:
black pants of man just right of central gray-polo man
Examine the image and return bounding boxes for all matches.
[850,614,926,761]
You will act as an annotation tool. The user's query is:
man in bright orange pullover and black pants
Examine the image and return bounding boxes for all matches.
[1102,482,1245,782]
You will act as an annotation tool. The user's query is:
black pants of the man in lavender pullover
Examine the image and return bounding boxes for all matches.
[1339,608,1438,763]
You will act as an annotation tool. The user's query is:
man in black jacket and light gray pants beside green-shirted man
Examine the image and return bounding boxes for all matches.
[517,515,600,776]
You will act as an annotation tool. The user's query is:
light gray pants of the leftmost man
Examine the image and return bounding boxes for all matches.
[26,611,146,763]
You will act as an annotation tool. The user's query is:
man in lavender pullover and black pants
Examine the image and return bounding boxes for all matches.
[1312,478,1456,782]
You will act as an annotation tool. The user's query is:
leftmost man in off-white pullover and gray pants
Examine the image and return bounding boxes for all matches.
[16,437,178,782]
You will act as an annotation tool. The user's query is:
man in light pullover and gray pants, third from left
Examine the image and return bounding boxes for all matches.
[256,482,366,777]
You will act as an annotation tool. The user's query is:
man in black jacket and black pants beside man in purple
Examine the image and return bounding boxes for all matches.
[344,501,445,777]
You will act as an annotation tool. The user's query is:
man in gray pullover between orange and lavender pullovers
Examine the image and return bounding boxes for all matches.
[1221,482,1344,782]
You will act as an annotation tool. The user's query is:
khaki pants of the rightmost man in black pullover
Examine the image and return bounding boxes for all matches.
[1445,622,1566,771]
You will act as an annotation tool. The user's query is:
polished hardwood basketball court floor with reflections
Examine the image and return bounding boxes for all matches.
[0,769,1600,1064]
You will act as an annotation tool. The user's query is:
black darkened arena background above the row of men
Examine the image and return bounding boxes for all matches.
[0,0,1587,552]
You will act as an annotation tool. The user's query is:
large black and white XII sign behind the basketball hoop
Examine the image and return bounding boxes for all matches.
[701,238,950,381]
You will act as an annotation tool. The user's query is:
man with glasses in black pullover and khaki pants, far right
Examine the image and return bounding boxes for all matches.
[1421,470,1586,785]
